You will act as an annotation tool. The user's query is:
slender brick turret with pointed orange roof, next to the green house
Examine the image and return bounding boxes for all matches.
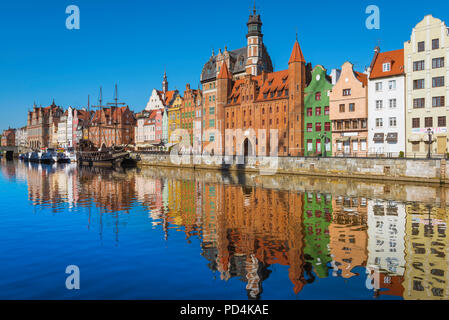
[288,39,306,156]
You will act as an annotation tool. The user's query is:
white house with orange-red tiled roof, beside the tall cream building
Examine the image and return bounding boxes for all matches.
[368,47,406,157]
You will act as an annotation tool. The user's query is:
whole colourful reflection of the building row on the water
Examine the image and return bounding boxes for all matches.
[2,164,449,299]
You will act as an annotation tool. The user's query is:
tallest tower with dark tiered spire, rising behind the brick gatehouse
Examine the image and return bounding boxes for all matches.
[246,4,263,76]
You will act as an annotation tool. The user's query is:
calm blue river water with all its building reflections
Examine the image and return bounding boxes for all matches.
[0,160,449,300]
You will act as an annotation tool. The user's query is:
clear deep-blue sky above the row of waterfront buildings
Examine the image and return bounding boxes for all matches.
[0,0,449,129]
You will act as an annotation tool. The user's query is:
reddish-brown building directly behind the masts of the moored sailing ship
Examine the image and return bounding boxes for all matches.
[89,106,136,147]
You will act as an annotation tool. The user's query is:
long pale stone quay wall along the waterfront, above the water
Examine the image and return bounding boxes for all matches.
[133,153,449,184]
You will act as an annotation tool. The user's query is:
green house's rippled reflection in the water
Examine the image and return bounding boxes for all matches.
[304,192,332,278]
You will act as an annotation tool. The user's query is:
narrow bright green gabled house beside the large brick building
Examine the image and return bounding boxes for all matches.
[304,65,332,157]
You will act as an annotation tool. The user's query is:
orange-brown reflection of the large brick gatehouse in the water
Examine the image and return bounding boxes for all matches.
[203,184,307,299]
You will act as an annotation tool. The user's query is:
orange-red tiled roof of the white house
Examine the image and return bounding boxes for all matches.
[370,49,404,79]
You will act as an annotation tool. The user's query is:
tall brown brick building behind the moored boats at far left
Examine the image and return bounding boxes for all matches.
[27,100,64,149]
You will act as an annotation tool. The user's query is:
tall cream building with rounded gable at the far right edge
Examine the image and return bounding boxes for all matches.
[404,15,449,157]
